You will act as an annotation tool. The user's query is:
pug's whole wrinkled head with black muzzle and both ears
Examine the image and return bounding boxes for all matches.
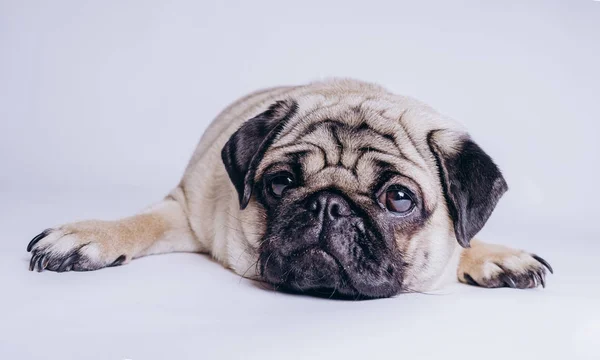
[222,97,506,297]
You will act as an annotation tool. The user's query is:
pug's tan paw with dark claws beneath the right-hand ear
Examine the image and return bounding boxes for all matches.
[458,243,553,289]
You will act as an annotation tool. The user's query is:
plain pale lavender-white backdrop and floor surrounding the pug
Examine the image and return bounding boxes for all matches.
[0,0,600,360]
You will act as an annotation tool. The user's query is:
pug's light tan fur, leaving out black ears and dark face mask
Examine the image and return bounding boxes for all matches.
[32,79,552,291]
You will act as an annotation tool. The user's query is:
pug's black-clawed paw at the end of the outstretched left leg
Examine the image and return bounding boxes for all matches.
[27,223,131,272]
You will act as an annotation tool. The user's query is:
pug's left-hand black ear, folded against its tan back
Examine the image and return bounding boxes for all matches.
[221,100,298,209]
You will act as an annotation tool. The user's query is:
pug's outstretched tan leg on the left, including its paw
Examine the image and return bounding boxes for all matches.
[27,190,206,272]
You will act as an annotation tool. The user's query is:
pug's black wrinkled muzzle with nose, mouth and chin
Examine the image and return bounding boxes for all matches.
[259,184,403,298]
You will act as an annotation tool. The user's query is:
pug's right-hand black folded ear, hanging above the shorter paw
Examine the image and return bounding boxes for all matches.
[427,130,508,247]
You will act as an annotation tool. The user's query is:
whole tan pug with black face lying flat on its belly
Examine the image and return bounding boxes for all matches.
[27,79,552,298]
